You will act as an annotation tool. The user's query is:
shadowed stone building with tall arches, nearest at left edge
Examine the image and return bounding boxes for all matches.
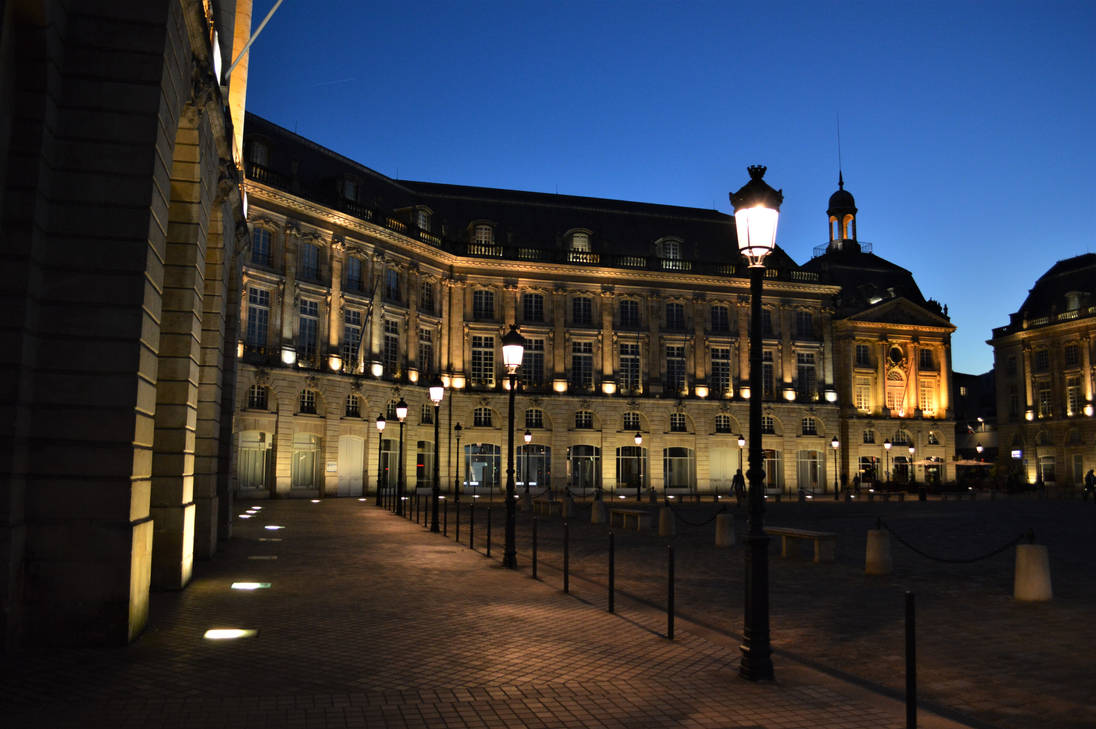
[0,0,251,649]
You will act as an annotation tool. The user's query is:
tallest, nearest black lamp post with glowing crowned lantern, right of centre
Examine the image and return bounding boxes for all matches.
[731,166,784,681]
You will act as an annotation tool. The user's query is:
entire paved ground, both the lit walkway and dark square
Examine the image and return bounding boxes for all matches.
[0,491,1096,729]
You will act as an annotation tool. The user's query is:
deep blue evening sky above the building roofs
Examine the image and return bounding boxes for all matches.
[248,0,1096,373]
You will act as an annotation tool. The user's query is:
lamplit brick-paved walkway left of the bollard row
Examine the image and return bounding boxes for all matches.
[0,500,986,729]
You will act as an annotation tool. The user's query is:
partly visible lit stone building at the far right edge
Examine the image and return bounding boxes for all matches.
[990,253,1096,488]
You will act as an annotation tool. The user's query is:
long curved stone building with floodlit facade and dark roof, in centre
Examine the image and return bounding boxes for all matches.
[235,115,952,498]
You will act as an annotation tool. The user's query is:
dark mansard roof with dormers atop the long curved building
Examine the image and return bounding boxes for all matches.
[244,113,799,274]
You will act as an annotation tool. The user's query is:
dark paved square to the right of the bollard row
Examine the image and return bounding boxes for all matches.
[488,488,1096,729]
